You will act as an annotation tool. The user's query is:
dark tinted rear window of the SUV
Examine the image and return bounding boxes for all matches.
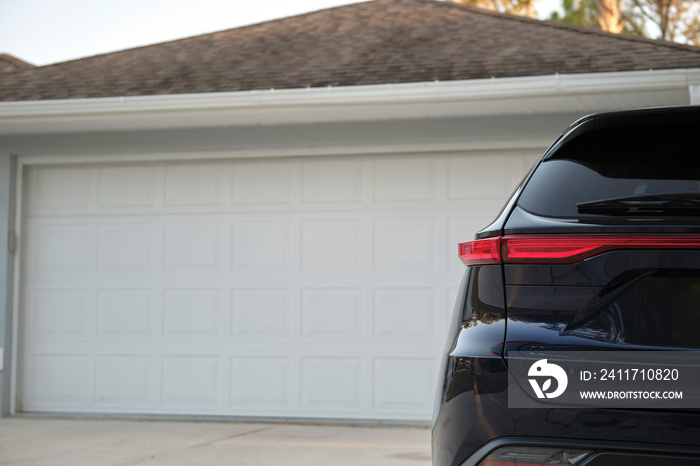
[518,124,700,217]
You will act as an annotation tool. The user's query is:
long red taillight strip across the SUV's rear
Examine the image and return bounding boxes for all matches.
[459,235,700,265]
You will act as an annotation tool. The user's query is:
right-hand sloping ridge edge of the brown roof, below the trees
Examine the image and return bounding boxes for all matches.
[416,0,700,53]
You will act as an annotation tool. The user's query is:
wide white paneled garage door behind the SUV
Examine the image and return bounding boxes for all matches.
[20,152,537,420]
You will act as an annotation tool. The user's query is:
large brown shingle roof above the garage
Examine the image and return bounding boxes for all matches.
[0,0,700,101]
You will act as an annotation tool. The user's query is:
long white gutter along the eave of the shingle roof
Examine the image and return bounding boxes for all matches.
[0,68,700,134]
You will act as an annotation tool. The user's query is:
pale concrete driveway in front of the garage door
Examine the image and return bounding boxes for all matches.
[0,417,430,466]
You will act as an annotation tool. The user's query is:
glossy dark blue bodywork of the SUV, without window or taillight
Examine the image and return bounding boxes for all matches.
[433,107,700,466]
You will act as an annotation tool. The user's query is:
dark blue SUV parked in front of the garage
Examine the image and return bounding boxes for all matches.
[432,107,700,466]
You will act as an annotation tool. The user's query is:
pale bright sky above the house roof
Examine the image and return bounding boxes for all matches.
[0,0,558,66]
